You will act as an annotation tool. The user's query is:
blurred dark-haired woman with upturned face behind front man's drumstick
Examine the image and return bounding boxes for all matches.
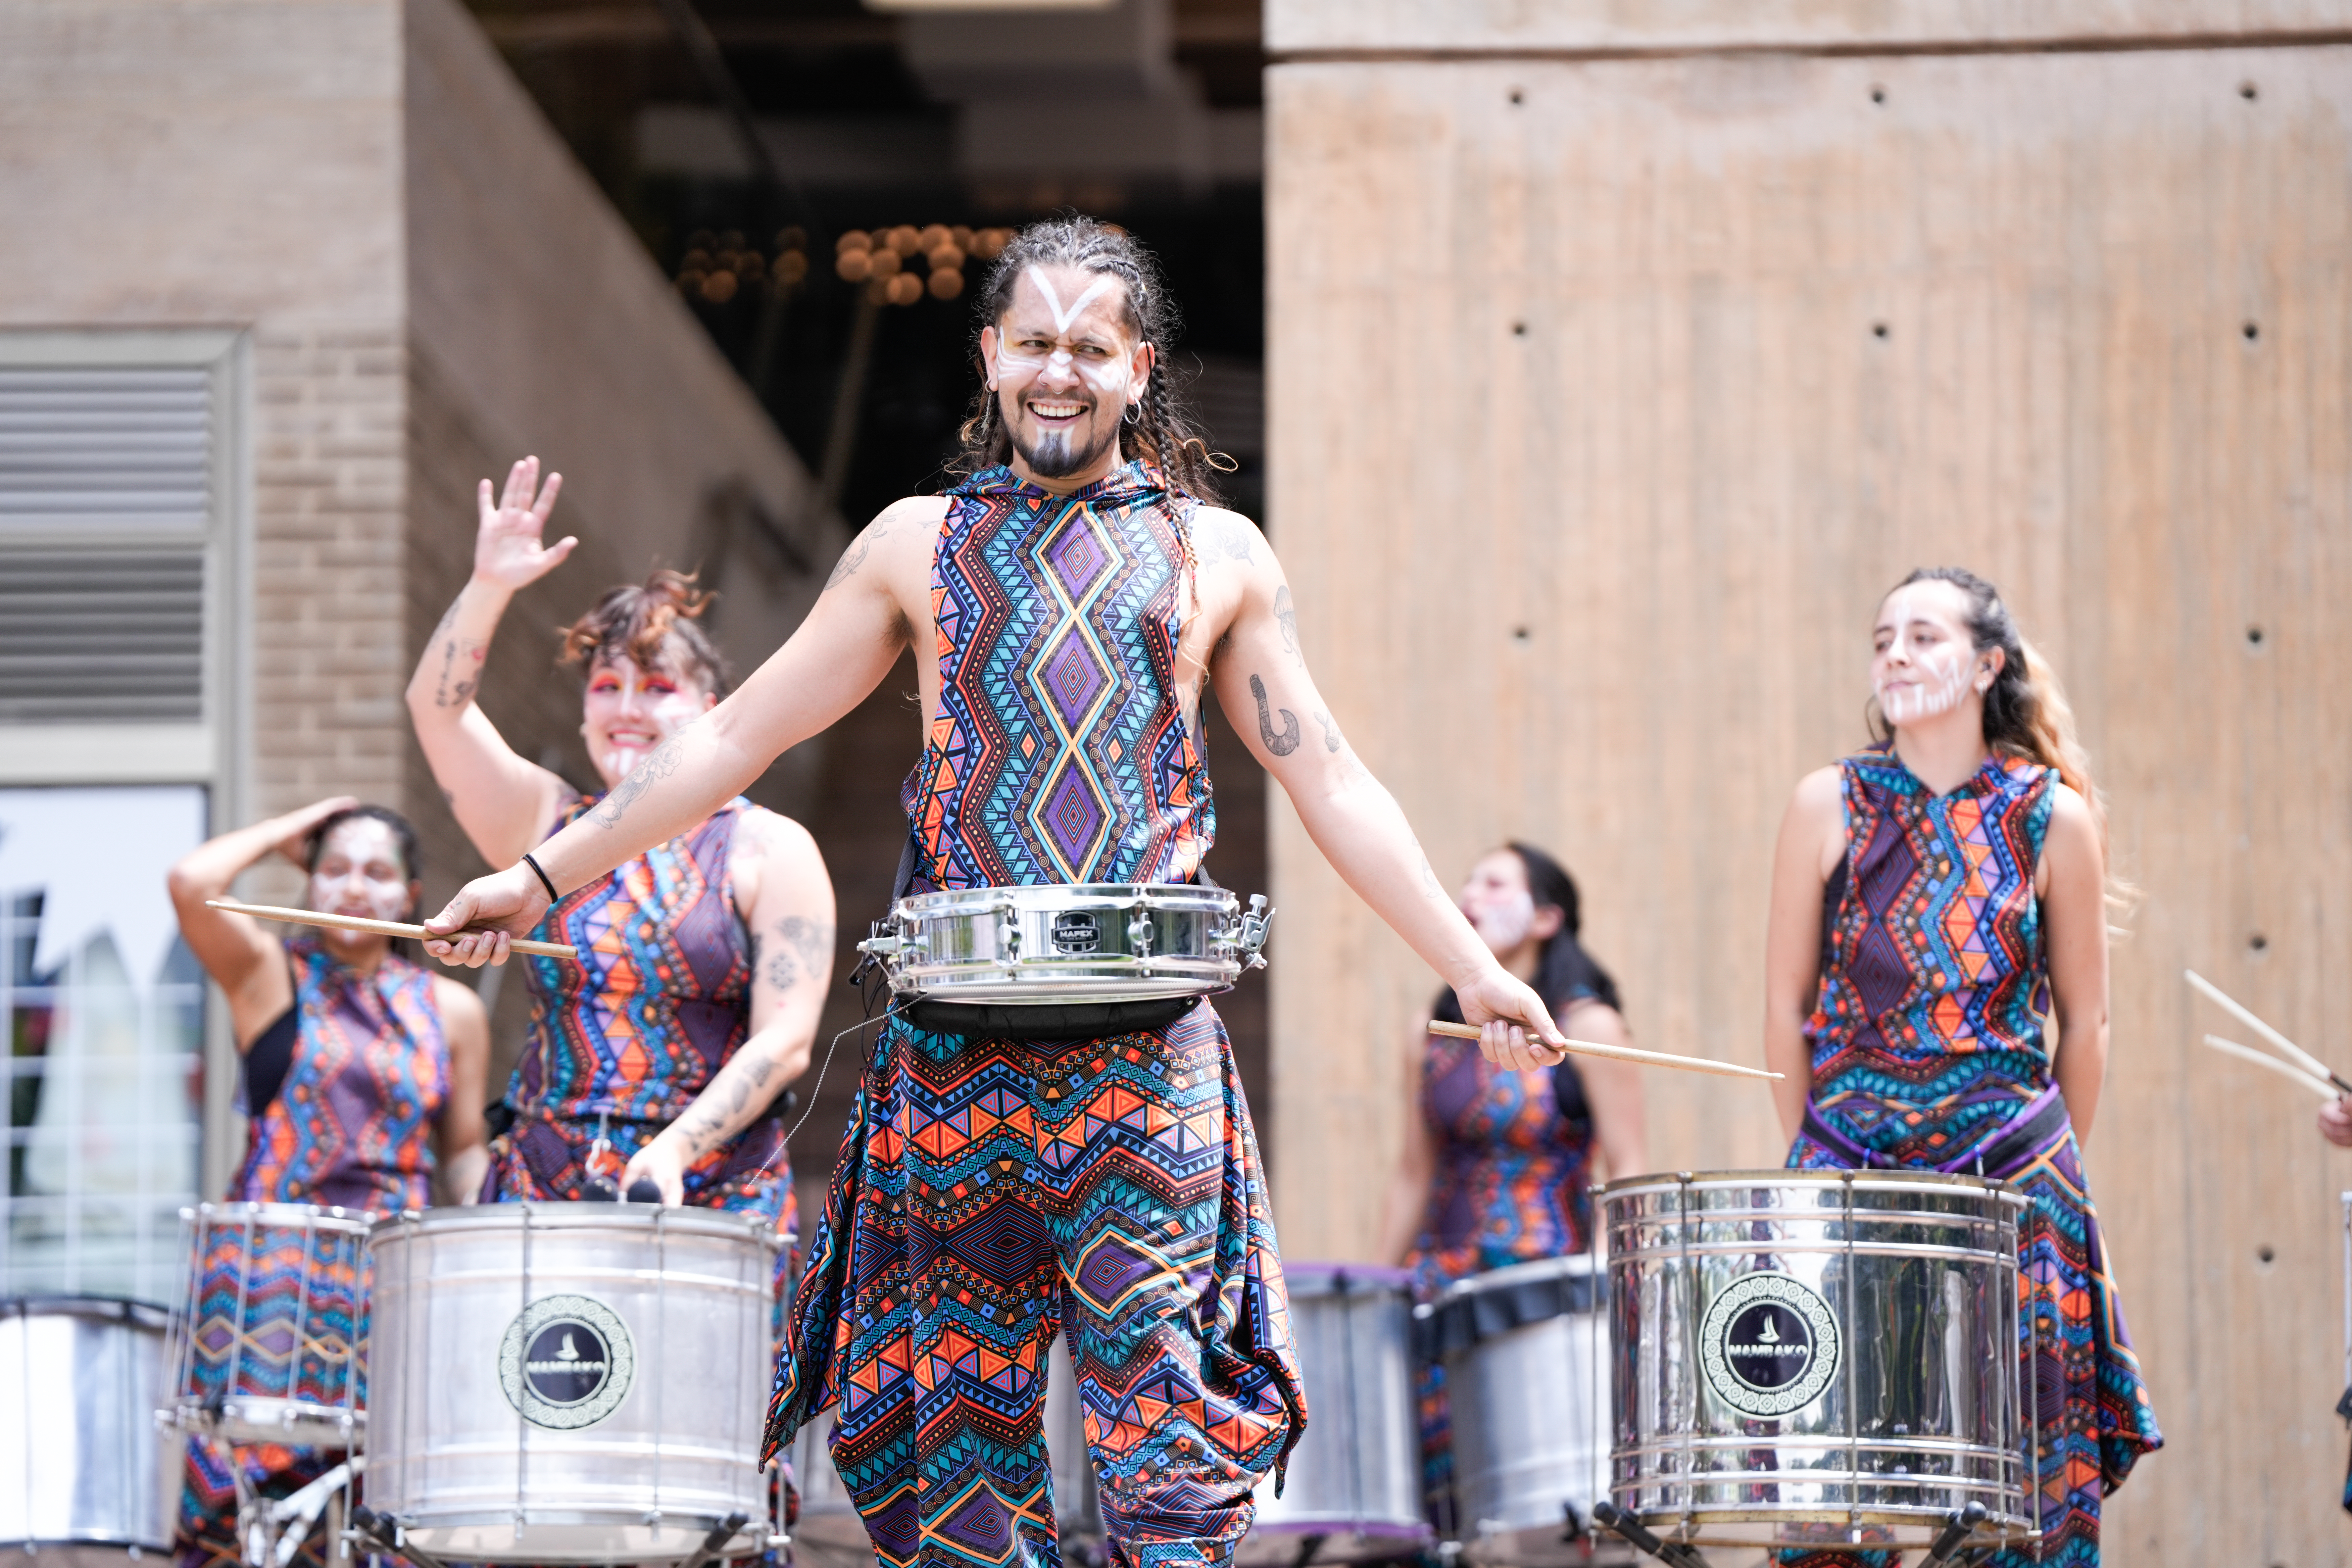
[1381,844,1649,1533]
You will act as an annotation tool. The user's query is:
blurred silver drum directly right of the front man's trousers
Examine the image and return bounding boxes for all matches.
[1237,1262,1430,1563]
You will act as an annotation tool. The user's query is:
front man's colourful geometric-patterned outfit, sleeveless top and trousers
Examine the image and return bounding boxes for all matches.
[769,463,1305,1568]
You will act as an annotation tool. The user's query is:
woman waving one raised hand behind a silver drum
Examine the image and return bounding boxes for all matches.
[409,458,833,1232]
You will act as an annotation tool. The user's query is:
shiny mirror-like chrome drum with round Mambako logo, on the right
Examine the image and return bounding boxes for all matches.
[1602,1171,2035,1549]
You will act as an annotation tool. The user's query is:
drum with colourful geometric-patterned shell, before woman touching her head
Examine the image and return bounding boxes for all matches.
[169,1204,369,1448]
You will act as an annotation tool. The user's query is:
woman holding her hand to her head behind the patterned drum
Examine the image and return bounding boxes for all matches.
[169,799,489,1568]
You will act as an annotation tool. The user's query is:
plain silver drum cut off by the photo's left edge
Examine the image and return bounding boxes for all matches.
[0,1297,184,1563]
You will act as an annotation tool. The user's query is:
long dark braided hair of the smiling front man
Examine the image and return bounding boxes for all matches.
[948,216,1230,505]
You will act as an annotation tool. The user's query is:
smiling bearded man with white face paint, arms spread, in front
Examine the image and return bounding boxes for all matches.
[430,218,1562,1568]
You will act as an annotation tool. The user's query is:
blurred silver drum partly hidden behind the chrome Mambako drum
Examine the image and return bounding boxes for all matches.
[1437,1255,1613,1563]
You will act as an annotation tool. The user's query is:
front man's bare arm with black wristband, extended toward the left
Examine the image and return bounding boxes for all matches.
[426,498,941,966]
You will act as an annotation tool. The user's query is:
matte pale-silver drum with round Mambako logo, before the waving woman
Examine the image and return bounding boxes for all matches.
[367,1204,776,1563]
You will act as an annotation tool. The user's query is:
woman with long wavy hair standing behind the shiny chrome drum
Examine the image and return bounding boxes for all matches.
[1764,567,2164,1568]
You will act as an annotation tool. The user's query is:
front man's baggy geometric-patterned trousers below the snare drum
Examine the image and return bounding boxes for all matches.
[767,1001,1305,1568]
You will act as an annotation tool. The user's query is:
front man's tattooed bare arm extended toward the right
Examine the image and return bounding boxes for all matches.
[1209,512,1566,1067]
